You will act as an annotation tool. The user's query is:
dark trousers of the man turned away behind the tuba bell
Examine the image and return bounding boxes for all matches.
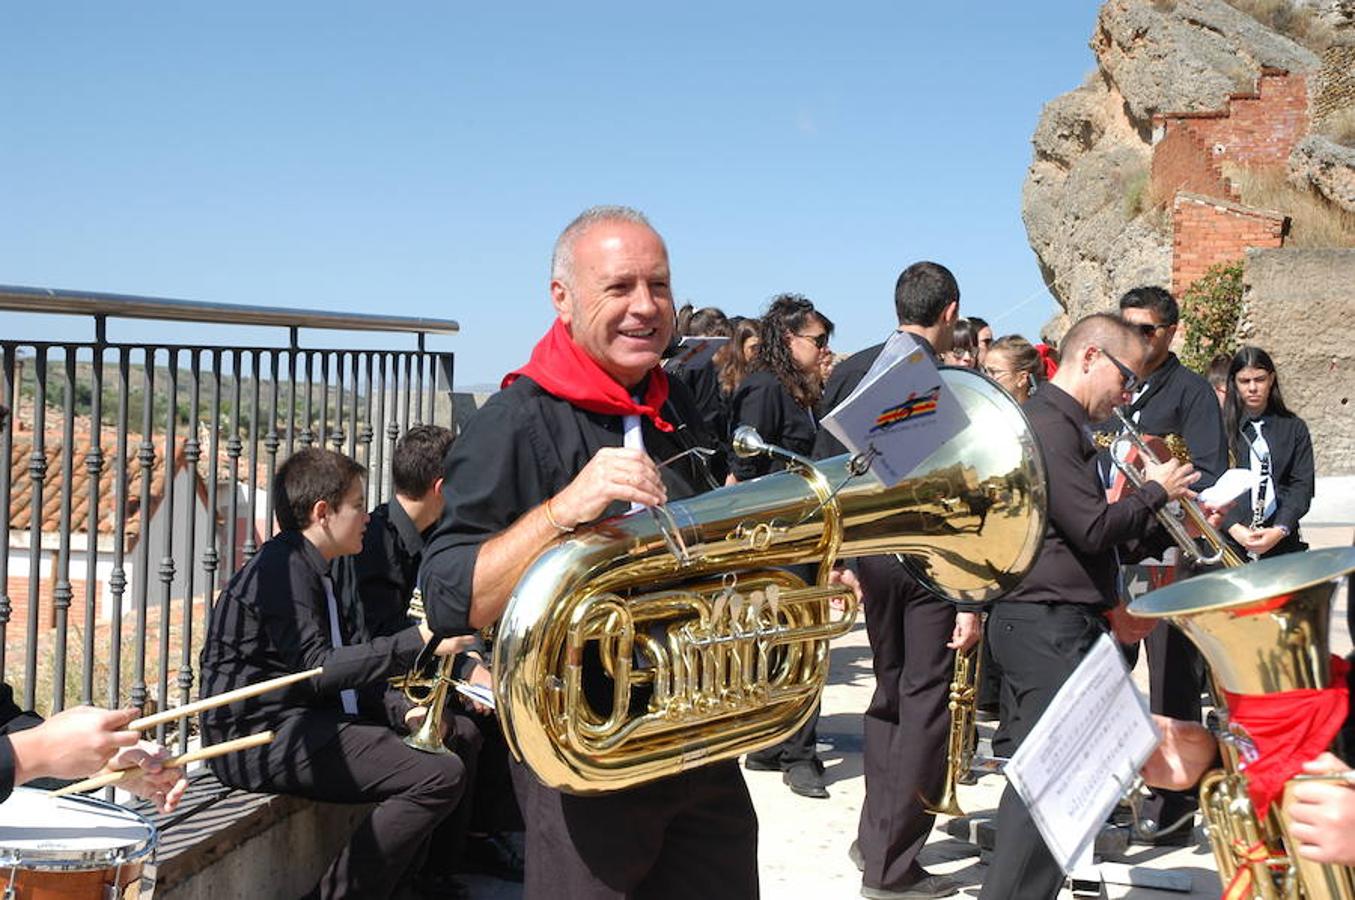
[856,556,955,891]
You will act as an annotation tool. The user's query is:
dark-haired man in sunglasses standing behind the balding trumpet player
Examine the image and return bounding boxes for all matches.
[1103,287,1228,844]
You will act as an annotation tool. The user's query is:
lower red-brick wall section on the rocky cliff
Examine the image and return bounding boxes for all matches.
[1172,191,1285,297]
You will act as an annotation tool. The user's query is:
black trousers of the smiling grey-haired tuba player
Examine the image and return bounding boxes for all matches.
[514,760,757,900]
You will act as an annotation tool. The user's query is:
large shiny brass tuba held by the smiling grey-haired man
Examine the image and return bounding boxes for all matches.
[493,370,1046,793]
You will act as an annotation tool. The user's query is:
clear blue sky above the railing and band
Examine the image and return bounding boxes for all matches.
[0,0,1096,384]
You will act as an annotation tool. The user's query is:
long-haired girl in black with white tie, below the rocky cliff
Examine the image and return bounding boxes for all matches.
[1224,347,1314,558]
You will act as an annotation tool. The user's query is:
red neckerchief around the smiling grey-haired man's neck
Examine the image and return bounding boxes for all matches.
[500,319,673,431]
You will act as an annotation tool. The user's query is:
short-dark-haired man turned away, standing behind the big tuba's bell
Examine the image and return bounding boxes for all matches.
[814,262,978,900]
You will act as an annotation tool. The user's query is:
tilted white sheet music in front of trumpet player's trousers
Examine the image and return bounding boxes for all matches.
[1005,634,1160,872]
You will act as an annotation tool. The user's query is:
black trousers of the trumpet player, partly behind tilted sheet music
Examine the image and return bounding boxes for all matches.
[978,602,1108,900]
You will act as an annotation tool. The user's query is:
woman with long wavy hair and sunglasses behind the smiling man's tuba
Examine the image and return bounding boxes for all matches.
[729,294,833,800]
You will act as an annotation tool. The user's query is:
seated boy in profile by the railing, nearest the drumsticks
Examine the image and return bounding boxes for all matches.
[202,449,466,897]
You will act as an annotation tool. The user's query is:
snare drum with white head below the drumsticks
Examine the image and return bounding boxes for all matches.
[0,788,156,900]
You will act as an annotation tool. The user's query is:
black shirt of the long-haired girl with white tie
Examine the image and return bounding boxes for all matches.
[1224,413,1316,549]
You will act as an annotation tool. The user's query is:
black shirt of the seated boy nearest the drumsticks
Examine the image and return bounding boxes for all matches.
[202,531,423,741]
